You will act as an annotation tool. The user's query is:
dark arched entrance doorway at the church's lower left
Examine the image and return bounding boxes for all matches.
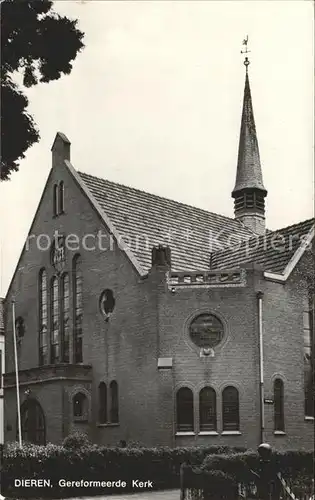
[21,399,46,445]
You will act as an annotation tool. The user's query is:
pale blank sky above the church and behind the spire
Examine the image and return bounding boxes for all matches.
[0,0,314,296]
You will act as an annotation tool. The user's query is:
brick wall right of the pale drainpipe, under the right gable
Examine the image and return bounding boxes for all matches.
[263,254,314,449]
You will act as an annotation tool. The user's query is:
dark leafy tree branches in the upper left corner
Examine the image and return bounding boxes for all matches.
[0,0,84,180]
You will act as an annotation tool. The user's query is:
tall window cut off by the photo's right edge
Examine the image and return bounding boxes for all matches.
[303,293,314,417]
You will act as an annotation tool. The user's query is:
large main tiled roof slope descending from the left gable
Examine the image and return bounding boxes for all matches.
[78,172,253,271]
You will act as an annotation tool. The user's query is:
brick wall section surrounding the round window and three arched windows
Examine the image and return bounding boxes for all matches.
[159,270,259,447]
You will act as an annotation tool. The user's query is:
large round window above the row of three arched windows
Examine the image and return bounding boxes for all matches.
[189,314,224,348]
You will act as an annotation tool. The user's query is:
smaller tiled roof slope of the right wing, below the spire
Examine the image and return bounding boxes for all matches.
[212,219,314,274]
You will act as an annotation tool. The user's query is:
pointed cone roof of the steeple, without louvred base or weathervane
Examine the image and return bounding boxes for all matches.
[232,70,267,195]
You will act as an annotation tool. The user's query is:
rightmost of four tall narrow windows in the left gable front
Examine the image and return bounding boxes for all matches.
[73,255,83,363]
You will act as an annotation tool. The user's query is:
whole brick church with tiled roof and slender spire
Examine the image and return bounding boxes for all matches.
[4,59,314,449]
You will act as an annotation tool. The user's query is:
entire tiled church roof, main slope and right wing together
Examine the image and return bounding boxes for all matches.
[78,172,314,274]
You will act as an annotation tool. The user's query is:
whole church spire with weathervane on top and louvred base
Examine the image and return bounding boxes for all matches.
[232,37,267,234]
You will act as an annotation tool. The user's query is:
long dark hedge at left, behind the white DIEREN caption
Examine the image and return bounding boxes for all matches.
[1,436,244,498]
